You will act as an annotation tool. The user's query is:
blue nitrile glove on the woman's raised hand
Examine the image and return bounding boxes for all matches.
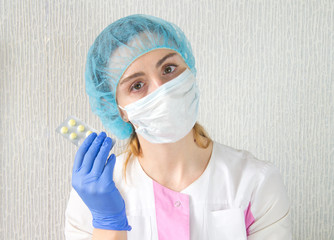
[72,132,131,231]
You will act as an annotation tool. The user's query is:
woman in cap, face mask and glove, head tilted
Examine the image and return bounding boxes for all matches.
[65,14,291,240]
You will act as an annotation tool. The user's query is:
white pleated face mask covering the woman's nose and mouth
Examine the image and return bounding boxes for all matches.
[119,68,199,143]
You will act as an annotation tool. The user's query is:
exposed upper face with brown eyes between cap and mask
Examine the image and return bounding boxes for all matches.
[116,49,188,121]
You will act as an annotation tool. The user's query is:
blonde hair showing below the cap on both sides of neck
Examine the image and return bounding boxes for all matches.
[123,122,212,181]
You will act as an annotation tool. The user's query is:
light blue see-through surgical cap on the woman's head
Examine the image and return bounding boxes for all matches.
[85,14,196,139]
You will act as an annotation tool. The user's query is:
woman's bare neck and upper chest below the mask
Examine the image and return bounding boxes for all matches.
[138,131,212,191]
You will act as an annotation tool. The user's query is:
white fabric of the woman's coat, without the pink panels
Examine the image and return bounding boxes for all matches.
[65,142,292,240]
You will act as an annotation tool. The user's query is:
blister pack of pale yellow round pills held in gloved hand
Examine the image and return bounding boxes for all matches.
[56,116,115,146]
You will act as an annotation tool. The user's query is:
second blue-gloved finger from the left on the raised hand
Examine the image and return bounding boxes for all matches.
[81,132,107,173]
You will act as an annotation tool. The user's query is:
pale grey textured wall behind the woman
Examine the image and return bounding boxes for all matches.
[0,0,334,240]
